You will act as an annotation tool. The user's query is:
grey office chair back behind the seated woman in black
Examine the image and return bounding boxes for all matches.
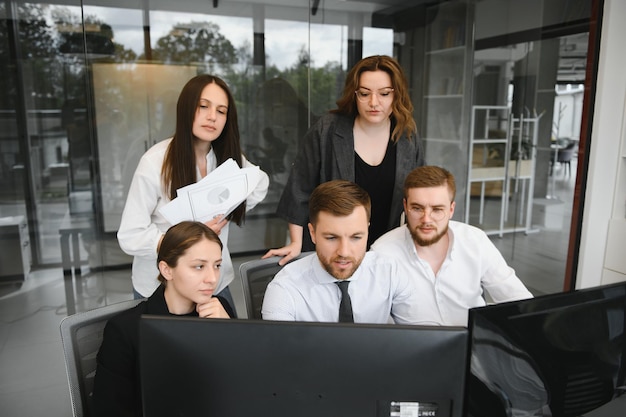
[60,300,143,417]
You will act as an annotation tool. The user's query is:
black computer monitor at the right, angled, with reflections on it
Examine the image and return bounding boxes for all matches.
[466,283,626,417]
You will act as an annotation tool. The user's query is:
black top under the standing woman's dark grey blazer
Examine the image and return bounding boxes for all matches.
[354,140,396,249]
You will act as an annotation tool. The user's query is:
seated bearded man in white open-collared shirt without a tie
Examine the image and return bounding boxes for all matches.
[372,166,532,326]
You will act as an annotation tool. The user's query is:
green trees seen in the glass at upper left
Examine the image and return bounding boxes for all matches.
[0,4,345,117]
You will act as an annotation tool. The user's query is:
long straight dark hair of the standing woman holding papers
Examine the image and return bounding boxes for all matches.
[161,74,246,225]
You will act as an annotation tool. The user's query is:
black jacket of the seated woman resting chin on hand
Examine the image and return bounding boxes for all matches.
[93,285,234,417]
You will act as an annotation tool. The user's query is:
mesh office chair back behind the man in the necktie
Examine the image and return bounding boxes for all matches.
[239,252,315,320]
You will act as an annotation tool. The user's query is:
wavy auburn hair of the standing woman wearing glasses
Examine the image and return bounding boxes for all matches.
[331,55,417,142]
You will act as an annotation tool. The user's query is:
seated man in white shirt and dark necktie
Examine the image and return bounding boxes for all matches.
[261,180,418,324]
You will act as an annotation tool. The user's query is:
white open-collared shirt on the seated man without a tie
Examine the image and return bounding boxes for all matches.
[372,220,532,326]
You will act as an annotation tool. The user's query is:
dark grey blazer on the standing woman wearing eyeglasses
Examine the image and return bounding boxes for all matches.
[276,113,424,251]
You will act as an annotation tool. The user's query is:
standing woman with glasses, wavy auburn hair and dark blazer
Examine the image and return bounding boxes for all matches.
[263,55,424,264]
